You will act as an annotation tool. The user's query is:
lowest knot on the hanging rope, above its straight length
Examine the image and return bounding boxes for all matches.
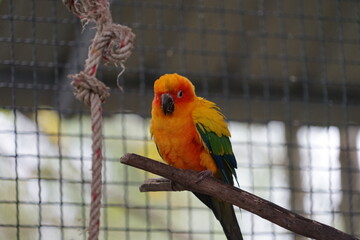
[69,71,110,106]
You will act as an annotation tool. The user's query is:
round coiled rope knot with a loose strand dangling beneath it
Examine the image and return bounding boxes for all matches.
[99,24,135,66]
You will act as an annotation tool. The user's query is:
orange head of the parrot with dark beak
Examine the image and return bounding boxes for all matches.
[153,73,196,116]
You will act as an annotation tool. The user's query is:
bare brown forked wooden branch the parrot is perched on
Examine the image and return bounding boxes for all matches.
[120,154,360,240]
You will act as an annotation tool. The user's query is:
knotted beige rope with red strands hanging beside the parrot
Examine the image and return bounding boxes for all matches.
[63,0,135,240]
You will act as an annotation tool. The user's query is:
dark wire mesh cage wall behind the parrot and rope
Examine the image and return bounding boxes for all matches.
[0,0,360,240]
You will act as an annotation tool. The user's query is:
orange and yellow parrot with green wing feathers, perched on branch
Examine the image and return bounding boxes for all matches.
[150,73,243,240]
